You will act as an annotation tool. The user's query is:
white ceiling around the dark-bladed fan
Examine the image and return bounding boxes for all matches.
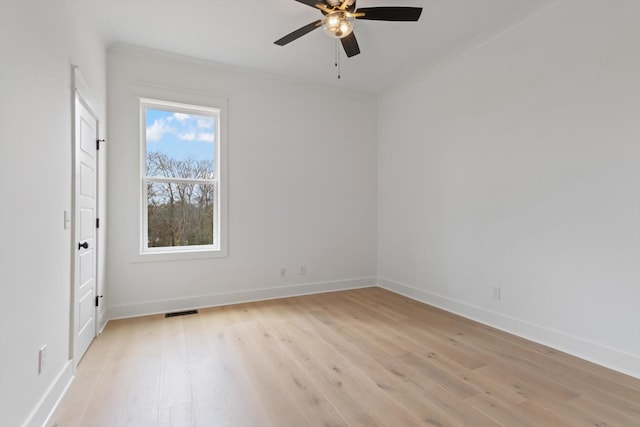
[71,0,549,94]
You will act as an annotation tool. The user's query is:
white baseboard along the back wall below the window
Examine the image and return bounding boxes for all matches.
[108,277,377,319]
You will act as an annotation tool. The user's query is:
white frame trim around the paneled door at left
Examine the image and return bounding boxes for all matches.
[69,65,104,364]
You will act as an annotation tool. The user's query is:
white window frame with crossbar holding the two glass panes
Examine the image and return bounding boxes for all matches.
[137,97,227,261]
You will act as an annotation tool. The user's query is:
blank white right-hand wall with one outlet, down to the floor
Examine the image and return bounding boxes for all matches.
[378,0,640,376]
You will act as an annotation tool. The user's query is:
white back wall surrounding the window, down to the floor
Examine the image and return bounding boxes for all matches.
[108,45,377,317]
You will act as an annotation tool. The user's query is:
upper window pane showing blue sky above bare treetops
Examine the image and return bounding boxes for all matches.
[145,108,216,179]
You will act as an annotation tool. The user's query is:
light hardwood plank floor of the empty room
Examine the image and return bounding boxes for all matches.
[48,288,640,427]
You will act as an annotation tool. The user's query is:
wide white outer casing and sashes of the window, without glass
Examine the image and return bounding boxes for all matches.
[134,91,228,262]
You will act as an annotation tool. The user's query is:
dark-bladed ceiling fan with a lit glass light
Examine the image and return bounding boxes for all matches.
[274,0,422,58]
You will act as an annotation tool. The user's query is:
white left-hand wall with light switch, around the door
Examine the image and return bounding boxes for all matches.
[0,1,106,426]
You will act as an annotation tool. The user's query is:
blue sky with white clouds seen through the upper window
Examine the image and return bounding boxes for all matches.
[145,108,216,161]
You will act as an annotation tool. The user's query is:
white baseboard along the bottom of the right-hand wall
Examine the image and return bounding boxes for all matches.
[378,278,640,378]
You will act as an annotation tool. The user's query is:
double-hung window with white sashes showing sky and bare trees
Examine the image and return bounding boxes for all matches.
[140,99,222,255]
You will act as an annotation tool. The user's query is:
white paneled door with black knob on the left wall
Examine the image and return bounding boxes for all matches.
[73,97,98,363]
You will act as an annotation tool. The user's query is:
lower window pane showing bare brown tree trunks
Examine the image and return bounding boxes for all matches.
[147,183,214,248]
